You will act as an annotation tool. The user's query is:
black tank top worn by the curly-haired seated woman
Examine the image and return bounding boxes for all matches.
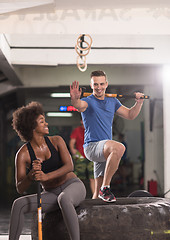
[26,137,63,173]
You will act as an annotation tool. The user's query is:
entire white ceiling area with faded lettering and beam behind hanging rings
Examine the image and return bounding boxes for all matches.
[0,0,170,87]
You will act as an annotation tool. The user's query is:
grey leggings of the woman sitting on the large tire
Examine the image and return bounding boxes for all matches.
[9,178,86,240]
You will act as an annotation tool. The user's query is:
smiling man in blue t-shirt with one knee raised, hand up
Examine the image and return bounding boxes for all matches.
[70,70,143,202]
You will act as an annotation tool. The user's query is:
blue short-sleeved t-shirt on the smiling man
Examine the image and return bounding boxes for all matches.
[81,94,122,148]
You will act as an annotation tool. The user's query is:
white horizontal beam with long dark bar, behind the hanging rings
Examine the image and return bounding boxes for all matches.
[1,34,170,66]
